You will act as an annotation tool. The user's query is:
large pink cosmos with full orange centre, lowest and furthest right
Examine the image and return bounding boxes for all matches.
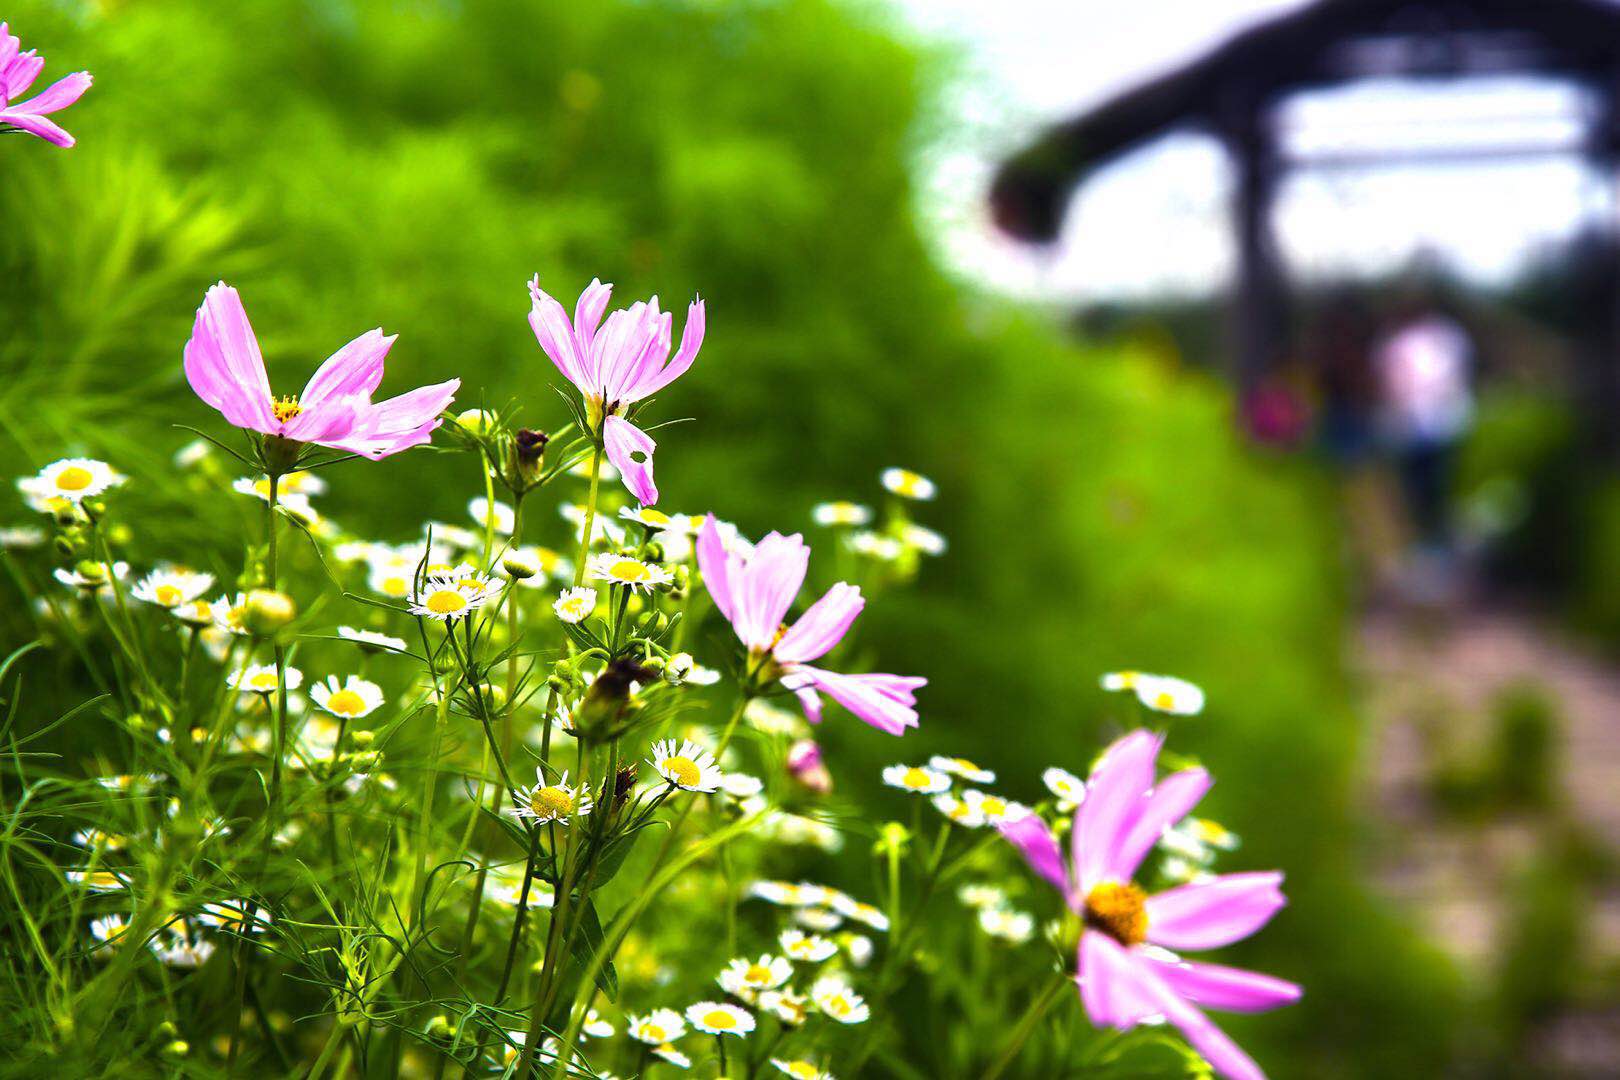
[998,730,1301,1080]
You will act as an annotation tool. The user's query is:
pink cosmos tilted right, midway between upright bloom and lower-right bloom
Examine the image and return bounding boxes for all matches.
[698,515,928,735]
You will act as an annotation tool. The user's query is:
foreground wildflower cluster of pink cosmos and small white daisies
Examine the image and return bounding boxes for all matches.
[0,57,1299,1080]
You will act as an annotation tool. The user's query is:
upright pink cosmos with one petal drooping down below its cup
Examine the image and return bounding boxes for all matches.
[528,275,705,505]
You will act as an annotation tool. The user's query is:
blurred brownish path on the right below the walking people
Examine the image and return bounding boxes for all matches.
[1351,606,1620,1075]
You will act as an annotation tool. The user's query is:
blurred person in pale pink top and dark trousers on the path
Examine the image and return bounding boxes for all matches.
[1374,300,1474,597]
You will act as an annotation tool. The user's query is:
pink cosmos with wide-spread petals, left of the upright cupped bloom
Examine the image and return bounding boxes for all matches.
[185,282,462,458]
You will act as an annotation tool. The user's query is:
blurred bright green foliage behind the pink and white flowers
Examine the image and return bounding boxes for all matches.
[12,0,1600,1077]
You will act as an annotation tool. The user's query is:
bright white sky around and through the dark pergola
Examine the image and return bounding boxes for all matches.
[894,0,1614,300]
